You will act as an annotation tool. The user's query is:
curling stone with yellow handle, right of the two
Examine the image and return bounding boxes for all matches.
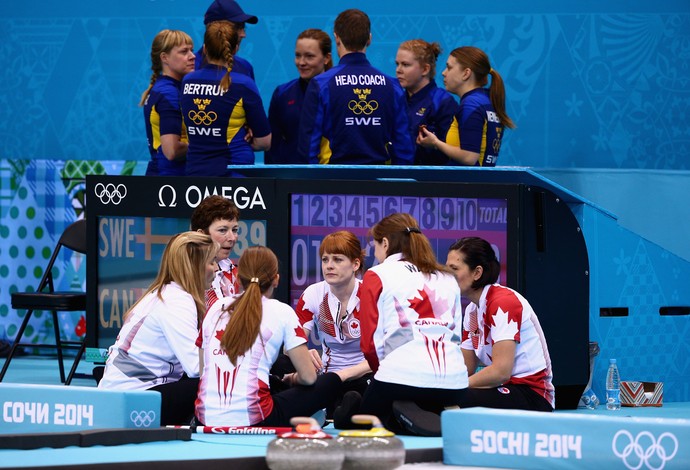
[337,415,405,470]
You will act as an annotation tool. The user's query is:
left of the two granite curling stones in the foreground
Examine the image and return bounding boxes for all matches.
[266,417,345,470]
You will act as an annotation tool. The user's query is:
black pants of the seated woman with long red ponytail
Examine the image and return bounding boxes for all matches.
[256,372,343,426]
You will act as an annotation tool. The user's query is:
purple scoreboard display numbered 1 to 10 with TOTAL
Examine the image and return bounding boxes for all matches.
[290,193,509,306]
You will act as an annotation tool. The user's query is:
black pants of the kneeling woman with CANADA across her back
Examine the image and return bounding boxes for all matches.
[359,379,467,433]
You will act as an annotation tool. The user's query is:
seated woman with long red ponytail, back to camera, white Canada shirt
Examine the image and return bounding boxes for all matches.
[196,246,349,426]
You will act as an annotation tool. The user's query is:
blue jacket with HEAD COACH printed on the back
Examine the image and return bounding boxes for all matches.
[298,52,415,165]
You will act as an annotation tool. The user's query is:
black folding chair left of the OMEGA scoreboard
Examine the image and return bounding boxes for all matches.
[0,219,86,385]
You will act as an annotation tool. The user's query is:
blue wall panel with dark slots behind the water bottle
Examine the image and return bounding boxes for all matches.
[578,205,690,401]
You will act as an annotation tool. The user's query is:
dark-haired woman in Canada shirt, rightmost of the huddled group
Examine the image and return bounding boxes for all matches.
[446,237,555,411]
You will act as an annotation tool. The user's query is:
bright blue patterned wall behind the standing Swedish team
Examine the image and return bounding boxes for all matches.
[0,0,690,169]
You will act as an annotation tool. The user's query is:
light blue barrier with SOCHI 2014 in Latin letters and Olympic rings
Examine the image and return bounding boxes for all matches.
[441,408,690,470]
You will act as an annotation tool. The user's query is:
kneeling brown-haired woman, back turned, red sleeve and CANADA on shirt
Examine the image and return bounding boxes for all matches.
[334,213,467,432]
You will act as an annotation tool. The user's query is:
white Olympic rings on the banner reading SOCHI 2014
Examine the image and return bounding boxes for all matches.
[611,430,678,470]
